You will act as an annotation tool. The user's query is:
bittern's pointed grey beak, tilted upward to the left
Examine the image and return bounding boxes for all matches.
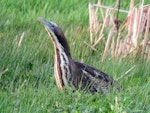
[37,17,54,31]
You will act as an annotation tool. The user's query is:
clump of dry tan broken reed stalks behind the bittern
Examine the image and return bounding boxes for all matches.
[89,0,150,61]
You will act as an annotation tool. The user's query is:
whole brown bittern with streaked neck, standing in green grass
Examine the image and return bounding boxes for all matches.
[38,17,120,93]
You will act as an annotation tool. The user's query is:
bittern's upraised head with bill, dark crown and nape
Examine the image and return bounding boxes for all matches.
[38,17,70,55]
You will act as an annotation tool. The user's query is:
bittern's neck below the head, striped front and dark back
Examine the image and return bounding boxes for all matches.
[53,37,71,90]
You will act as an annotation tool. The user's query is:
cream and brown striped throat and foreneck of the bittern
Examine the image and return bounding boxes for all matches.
[54,44,71,90]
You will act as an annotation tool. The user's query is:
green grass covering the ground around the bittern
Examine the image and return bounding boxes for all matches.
[0,0,150,113]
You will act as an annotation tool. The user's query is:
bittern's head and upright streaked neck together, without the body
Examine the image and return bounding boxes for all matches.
[38,18,71,90]
